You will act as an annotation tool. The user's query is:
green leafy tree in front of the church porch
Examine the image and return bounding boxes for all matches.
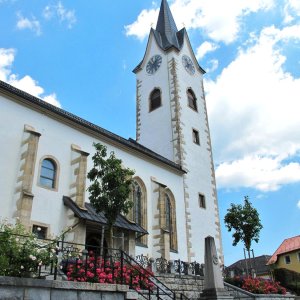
[87,143,134,248]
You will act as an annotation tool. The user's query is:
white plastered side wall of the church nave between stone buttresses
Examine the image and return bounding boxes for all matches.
[0,93,186,259]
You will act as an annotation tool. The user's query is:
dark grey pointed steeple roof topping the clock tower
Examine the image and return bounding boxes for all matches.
[153,0,183,50]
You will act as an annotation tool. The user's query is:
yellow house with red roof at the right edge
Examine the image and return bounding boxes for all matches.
[268,235,300,273]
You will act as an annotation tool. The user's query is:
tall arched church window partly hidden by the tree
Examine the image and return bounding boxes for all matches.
[132,179,147,246]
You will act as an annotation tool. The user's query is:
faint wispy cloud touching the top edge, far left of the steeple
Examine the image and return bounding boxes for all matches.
[43,1,77,29]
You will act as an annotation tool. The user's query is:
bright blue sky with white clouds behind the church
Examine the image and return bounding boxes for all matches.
[0,0,300,265]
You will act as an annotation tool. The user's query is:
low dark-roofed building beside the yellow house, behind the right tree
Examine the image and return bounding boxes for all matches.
[225,255,271,279]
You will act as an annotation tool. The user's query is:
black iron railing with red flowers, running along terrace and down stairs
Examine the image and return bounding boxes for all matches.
[0,233,187,300]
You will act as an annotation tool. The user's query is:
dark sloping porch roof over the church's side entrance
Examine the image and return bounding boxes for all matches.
[63,196,148,235]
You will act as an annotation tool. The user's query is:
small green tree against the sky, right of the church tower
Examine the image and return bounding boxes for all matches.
[224,196,263,276]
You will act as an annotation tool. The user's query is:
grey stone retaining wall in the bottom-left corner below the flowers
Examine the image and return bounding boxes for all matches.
[0,276,129,300]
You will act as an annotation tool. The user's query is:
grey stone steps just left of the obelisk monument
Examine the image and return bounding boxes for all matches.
[156,274,204,300]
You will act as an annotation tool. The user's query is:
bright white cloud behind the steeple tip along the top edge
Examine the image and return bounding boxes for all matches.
[125,0,274,43]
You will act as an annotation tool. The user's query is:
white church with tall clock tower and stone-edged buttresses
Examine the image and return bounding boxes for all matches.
[0,0,223,263]
